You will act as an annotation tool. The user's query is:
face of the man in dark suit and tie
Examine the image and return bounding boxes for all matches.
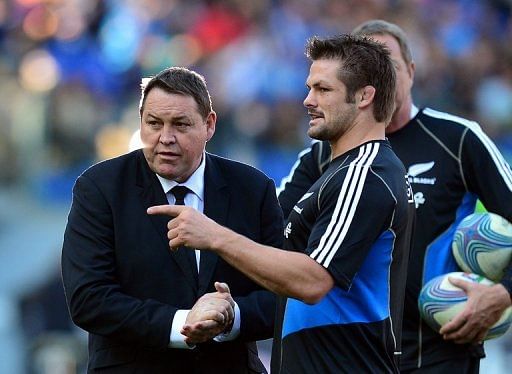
[140,87,216,182]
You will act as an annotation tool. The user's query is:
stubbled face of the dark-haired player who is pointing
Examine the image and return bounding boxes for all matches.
[304,59,357,141]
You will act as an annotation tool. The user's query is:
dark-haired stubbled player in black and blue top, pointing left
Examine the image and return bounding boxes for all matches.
[148,35,414,374]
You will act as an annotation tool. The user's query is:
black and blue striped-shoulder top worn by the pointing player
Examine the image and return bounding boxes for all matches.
[281,141,414,373]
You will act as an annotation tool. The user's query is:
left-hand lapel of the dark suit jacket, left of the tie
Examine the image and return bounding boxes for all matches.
[136,151,197,294]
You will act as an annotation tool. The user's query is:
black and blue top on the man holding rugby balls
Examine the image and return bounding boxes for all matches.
[279,108,512,369]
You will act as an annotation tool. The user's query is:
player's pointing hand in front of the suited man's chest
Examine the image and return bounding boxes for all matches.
[147,205,223,250]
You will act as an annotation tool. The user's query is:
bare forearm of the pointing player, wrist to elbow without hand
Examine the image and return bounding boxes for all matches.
[210,226,334,303]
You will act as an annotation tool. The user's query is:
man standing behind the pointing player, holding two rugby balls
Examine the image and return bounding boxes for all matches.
[273,20,512,373]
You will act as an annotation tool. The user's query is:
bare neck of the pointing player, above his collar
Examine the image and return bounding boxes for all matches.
[330,121,386,159]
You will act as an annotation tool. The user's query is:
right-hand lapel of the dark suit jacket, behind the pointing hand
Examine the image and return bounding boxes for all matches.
[199,153,230,295]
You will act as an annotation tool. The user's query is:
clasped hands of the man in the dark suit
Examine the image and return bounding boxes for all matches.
[181,282,235,344]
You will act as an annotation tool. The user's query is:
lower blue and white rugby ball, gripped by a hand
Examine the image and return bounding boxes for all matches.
[418,272,512,340]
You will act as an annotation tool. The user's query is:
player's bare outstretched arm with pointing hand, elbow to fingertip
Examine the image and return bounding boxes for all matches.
[148,205,334,303]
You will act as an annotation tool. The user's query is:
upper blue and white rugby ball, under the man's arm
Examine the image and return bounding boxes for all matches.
[452,213,512,282]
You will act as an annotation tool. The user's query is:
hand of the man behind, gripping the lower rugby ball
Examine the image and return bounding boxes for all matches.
[439,277,511,344]
